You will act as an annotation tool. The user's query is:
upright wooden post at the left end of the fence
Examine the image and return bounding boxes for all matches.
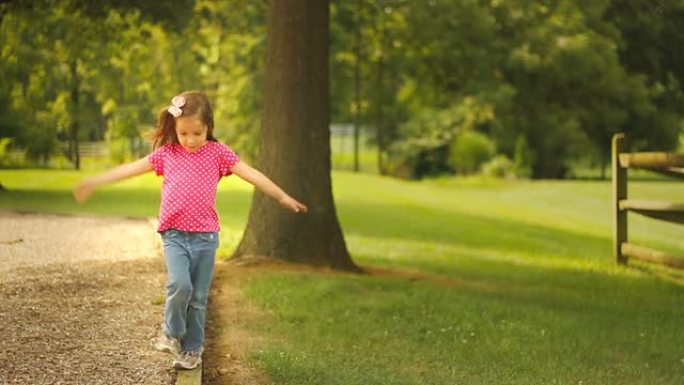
[612,133,627,265]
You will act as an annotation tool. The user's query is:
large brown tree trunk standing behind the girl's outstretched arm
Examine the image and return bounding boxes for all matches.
[234,0,357,270]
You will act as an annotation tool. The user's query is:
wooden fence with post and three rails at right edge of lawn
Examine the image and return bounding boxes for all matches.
[612,134,684,268]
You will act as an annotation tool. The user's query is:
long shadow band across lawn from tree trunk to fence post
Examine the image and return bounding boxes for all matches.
[338,201,611,259]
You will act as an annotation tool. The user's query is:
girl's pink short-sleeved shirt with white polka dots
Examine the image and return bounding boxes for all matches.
[147,141,240,232]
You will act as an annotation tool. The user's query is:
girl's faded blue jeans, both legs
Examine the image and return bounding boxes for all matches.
[161,229,218,352]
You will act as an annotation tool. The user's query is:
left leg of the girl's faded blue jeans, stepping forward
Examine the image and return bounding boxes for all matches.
[162,230,193,339]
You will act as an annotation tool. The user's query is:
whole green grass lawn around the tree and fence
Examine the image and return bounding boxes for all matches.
[0,170,684,385]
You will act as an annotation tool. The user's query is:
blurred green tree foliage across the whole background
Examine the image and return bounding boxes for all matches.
[0,0,684,177]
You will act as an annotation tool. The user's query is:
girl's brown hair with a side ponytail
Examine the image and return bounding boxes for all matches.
[150,91,217,150]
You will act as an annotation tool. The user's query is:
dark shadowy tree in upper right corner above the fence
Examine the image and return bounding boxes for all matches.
[604,0,684,150]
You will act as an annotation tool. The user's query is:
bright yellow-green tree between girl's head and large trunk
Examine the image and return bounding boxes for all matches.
[191,0,267,159]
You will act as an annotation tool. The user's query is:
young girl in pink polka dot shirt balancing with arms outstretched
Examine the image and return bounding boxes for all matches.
[74,91,307,369]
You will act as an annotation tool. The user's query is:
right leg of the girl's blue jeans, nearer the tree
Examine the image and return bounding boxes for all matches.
[181,233,218,351]
